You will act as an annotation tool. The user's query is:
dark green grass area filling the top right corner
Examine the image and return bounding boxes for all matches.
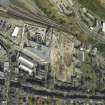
[78,0,105,20]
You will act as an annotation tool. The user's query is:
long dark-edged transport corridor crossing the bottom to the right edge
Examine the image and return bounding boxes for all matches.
[2,81,105,100]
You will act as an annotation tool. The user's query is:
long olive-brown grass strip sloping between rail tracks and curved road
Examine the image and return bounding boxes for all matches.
[33,0,88,42]
